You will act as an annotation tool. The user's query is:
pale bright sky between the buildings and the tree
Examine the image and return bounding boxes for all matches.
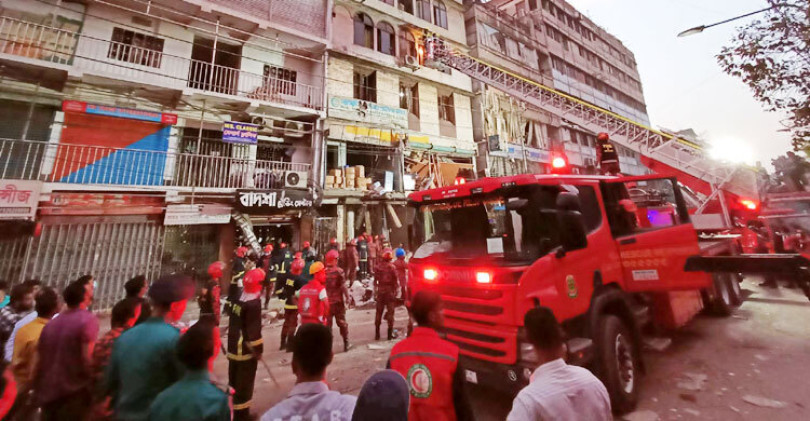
[568,0,791,167]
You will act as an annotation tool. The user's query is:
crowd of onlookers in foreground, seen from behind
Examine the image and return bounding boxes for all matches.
[0,275,611,421]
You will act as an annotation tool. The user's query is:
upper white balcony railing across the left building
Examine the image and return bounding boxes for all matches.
[0,16,323,109]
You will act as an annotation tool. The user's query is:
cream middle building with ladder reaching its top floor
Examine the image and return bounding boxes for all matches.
[319,0,476,245]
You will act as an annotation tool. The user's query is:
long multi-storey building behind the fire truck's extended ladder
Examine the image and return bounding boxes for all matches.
[465,0,649,175]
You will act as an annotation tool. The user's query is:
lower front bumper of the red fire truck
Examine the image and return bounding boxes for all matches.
[459,355,534,396]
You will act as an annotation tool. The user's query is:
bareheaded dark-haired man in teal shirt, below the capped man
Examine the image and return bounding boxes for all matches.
[144,315,226,421]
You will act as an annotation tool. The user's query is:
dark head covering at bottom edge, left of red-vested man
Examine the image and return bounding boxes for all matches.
[352,370,410,421]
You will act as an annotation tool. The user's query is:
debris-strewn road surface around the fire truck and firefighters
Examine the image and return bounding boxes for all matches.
[205,279,810,421]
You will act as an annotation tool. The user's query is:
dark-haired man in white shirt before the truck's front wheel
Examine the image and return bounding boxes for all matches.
[507,307,613,421]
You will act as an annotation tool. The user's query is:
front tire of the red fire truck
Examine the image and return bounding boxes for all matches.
[597,314,640,414]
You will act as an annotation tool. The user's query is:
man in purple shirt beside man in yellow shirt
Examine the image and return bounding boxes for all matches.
[34,277,98,421]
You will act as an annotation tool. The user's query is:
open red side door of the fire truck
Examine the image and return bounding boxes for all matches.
[602,177,711,292]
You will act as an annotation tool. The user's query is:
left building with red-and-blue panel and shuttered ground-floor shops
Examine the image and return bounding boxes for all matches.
[0,0,332,308]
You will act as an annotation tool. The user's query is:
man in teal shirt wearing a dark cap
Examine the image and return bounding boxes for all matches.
[105,274,194,421]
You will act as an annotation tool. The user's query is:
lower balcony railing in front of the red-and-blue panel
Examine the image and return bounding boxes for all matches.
[0,139,310,189]
